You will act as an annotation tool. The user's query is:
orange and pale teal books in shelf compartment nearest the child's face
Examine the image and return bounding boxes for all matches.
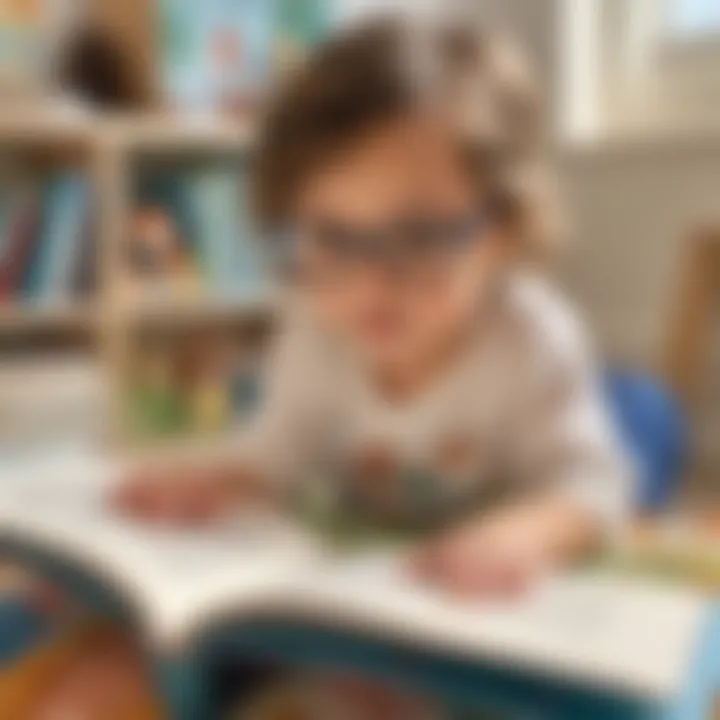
[126,163,266,300]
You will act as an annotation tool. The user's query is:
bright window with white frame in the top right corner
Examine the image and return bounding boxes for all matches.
[561,0,720,145]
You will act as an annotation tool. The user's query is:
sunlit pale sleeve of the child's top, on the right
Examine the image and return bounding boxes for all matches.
[510,296,632,534]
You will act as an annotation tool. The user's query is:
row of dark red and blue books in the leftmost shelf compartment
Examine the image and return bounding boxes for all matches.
[0,170,96,304]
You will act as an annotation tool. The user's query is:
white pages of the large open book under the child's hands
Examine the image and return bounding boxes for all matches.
[0,450,709,699]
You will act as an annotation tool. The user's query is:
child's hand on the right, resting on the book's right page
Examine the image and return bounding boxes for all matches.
[412,503,598,597]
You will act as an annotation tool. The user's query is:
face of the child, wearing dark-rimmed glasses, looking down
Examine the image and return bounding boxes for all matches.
[297,119,503,372]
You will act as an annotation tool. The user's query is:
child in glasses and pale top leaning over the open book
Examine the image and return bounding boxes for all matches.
[12,15,628,716]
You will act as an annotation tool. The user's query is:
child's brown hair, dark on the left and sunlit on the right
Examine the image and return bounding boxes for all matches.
[254,18,559,254]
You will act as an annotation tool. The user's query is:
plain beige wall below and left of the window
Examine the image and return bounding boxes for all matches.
[470,0,720,367]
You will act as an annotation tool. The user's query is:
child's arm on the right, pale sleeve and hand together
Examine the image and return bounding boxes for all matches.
[417,314,630,593]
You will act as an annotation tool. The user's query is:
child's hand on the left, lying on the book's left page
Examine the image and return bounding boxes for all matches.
[113,467,270,525]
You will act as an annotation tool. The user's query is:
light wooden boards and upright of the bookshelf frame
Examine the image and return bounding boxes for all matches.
[0,110,277,450]
